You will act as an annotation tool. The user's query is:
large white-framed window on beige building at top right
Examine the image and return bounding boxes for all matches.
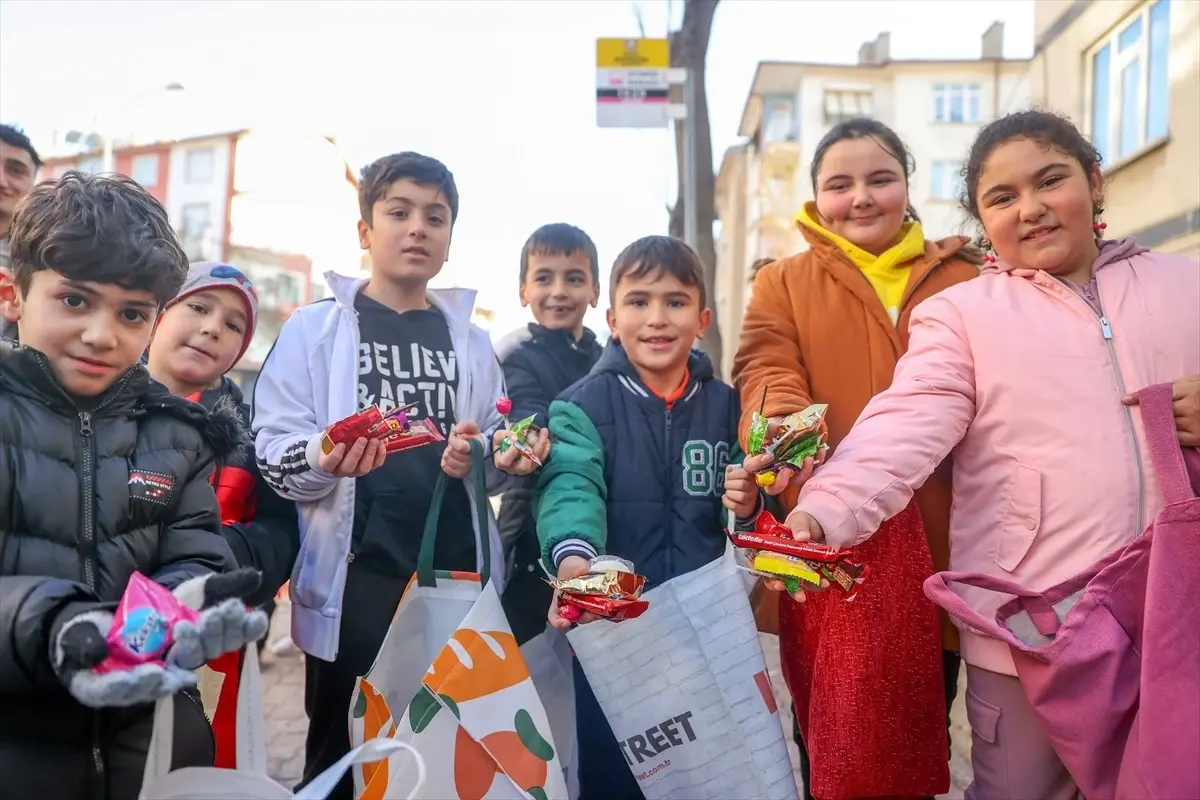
[1090,0,1171,163]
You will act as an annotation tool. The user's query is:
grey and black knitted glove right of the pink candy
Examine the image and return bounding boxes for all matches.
[167,567,270,669]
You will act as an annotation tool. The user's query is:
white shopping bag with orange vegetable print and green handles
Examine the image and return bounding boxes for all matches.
[349,441,566,800]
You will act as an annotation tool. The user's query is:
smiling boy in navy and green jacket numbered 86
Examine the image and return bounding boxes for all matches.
[536,236,761,800]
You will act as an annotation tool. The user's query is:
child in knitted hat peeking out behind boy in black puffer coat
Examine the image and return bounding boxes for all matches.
[146,261,300,769]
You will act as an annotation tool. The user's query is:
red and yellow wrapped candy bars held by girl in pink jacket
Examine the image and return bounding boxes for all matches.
[725,511,870,601]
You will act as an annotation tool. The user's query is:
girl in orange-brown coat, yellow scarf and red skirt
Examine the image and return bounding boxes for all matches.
[733,119,980,800]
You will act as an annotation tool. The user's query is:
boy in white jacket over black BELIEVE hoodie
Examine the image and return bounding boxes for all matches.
[253,152,516,798]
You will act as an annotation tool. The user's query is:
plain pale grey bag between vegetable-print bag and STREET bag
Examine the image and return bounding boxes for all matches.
[521,625,580,800]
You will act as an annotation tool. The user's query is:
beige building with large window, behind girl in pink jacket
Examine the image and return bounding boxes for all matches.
[1030,0,1200,258]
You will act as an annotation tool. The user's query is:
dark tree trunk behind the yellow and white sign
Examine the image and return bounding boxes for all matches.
[668,0,722,377]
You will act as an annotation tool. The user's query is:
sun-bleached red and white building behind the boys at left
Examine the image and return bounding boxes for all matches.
[42,128,364,384]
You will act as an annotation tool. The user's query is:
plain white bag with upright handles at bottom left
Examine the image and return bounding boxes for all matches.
[138,645,425,800]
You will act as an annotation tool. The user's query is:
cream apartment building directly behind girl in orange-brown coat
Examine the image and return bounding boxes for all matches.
[716,23,1030,374]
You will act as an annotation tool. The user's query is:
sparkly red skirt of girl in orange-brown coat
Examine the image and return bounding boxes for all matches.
[779,503,950,800]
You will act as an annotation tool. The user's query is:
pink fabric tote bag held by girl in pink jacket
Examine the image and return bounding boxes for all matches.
[925,384,1200,800]
